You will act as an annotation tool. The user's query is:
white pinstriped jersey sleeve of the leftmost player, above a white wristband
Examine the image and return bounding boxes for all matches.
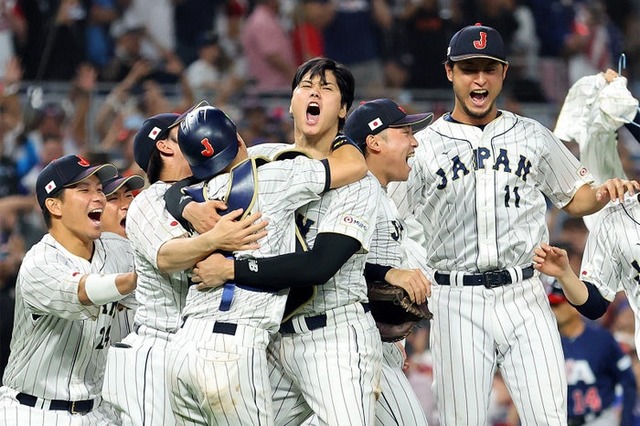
[18,248,100,320]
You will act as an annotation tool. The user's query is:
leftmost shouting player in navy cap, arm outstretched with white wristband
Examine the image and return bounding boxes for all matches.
[0,155,136,426]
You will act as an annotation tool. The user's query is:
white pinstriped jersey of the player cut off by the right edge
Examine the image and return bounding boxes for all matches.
[580,196,640,354]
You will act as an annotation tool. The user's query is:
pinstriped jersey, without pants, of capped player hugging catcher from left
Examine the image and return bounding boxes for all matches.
[127,182,188,333]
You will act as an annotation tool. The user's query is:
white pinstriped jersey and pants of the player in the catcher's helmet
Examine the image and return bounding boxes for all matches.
[167,156,327,425]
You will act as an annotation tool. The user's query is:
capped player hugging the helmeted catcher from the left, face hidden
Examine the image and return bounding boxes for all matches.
[103,108,266,426]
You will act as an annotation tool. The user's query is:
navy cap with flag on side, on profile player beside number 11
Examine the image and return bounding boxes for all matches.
[342,99,433,148]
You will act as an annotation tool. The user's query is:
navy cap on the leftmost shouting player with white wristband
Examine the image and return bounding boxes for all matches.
[36,155,118,210]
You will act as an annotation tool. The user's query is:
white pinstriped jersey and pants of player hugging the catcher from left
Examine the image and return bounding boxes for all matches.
[103,182,188,426]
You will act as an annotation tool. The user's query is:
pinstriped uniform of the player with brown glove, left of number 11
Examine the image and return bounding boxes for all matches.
[367,185,427,426]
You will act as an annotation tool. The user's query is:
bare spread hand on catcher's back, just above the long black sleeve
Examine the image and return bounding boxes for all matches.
[207,209,268,251]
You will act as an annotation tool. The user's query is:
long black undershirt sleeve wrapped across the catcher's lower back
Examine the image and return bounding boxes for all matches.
[234,233,360,289]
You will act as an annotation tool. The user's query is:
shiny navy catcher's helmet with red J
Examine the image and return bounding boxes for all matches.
[178,106,238,180]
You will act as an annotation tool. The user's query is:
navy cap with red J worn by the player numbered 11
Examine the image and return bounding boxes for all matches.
[447,23,509,65]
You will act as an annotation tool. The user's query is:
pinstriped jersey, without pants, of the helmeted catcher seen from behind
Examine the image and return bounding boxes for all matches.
[183,156,326,332]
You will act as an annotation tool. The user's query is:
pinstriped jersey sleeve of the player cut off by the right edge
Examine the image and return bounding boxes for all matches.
[580,214,622,302]
